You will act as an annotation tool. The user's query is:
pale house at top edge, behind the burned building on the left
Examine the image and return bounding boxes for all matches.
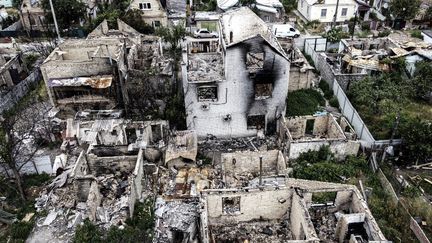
[129,0,168,28]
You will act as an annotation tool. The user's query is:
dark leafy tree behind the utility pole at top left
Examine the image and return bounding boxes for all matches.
[42,0,86,30]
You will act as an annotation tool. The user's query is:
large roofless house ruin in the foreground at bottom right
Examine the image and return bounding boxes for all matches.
[201,179,388,243]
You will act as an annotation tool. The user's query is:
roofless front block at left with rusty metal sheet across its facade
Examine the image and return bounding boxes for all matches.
[40,38,127,114]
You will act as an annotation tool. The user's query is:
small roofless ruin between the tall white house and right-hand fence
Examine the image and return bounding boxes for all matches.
[279,114,360,159]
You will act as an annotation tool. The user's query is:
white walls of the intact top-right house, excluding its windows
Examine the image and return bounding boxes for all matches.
[297,0,357,23]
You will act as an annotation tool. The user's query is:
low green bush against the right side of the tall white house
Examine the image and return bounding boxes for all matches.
[286,89,325,116]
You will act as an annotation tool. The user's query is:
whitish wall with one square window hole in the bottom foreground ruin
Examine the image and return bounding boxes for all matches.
[207,189,291,225]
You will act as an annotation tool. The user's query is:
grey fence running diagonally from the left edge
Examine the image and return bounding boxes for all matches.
[0,68,41,114]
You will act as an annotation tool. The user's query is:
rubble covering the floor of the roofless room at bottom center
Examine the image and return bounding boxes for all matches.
[212,219,292,243]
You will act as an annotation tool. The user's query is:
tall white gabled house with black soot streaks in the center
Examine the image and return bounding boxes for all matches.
[182,7,290,137]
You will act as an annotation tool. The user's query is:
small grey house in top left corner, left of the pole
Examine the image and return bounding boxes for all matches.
[19,0,48,31]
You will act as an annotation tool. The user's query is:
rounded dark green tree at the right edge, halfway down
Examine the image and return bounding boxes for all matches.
[400,118,432,163]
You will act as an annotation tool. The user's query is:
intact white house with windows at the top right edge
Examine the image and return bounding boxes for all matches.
[297,0,357,23]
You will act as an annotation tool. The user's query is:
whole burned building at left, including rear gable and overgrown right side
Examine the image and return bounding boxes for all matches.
[41,19,172,117]
